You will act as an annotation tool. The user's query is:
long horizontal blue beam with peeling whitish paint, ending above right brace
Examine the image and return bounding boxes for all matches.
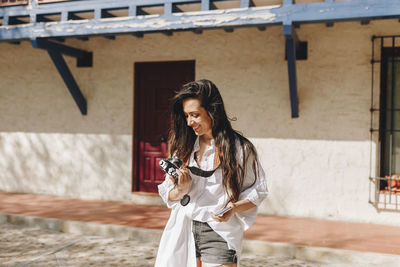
[0,8,282,40]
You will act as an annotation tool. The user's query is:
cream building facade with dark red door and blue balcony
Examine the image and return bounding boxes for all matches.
[0,1,400,225]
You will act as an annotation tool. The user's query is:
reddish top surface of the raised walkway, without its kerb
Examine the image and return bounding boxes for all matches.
[0,192,400,258]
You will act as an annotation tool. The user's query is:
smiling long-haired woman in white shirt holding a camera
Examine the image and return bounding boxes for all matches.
[155,80,267,267]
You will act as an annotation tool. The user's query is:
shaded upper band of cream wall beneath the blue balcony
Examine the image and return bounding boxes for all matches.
[0,26,371,141]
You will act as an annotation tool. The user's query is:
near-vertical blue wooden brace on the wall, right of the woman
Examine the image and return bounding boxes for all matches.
[283,24,299,118]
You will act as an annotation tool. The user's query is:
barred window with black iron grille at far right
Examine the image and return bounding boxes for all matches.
[369,36,400,211]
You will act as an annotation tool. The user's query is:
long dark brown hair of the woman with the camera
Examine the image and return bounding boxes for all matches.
[168,80,259,202]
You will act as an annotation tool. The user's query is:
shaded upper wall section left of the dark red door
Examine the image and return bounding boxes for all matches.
[0,42,133,135]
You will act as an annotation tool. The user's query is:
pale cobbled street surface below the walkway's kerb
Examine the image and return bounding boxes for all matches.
[0,224,322,267]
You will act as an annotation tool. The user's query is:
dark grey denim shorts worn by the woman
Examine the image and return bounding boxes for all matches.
[193,221,237,264]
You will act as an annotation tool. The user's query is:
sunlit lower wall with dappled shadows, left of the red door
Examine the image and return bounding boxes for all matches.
[0,133,131,199]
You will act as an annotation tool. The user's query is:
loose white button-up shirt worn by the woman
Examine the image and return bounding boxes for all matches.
[155,138,268,267]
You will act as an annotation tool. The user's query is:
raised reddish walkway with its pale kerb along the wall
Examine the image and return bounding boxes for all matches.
[0,193,400,266]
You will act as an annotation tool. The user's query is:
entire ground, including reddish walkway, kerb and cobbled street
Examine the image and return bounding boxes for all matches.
[0,192,400,267]
